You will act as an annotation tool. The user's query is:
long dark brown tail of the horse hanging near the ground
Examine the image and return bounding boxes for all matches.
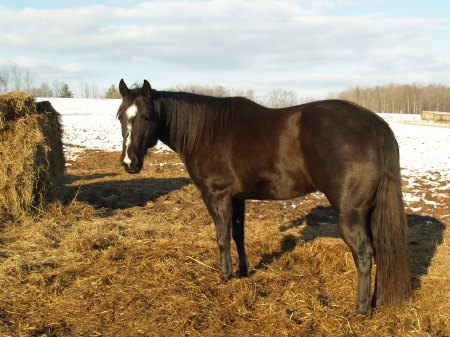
[370,123,411,306]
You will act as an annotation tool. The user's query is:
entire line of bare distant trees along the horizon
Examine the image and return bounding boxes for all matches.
[0,65,450,114]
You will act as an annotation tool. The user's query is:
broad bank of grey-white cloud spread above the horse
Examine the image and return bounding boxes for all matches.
[0,0,449,94]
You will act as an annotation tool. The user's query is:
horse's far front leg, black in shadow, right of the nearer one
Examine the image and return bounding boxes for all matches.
[231,199,249,277]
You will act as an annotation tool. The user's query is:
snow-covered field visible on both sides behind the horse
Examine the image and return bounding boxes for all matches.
[40,98,450,217]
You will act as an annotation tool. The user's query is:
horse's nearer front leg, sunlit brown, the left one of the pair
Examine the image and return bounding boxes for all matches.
[202,192,233,282]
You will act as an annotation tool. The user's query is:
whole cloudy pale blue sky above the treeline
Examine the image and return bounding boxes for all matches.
[0,0,450,99]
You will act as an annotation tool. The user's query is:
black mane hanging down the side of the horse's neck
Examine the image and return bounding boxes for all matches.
[153,91,237,153]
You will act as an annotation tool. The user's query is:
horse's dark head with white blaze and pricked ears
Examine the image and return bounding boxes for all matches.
[117,79,158,173]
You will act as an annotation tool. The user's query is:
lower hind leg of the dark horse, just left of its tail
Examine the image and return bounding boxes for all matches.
[338,207,373,314]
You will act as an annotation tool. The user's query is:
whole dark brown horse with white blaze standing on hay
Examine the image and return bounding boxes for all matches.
[117,79,411,314]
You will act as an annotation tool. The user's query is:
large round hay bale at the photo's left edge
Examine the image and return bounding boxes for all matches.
[0,92,64,219]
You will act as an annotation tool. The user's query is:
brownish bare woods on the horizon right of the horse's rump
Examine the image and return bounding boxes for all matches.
[333,84,450,114]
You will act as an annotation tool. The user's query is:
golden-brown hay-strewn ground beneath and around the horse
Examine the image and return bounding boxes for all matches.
[0,152,450,336]
